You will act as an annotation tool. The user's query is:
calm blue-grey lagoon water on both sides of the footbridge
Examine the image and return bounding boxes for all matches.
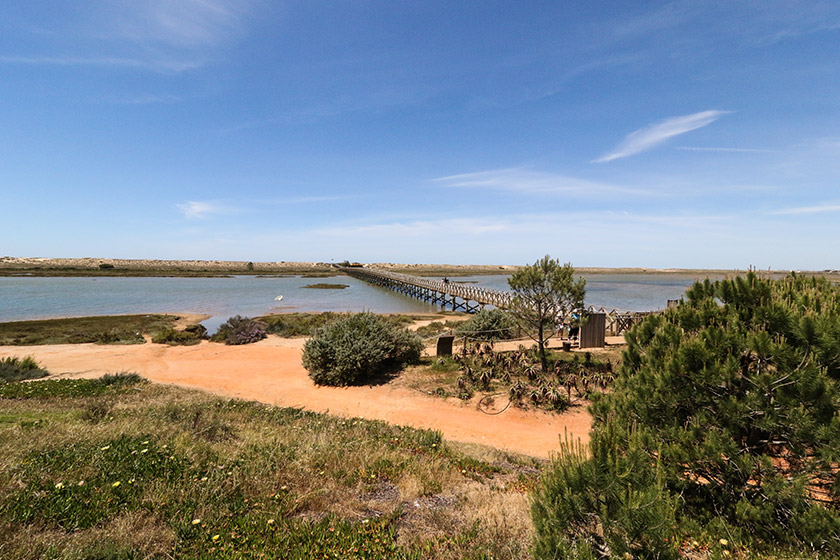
[0,274,720,330]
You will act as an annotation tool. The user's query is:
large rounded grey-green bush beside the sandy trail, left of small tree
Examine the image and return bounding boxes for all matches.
[303,313,423,386]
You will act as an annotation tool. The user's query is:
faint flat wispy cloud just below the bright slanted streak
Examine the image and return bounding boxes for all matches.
[432,167,650,195]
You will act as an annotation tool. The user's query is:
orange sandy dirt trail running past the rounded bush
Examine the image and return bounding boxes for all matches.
[0,336,590,457]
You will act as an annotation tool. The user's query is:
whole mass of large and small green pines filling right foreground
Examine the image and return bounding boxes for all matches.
[533,273,840,559]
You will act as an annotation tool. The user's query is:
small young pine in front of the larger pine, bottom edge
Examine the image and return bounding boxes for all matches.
[531,427,679,560]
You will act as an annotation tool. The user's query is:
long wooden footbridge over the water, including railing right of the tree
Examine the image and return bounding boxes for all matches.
[338,266,656,335]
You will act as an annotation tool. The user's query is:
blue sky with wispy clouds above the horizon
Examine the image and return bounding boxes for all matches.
[0,0,840,270]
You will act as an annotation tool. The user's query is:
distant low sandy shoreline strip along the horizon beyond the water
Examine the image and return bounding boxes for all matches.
[0,257,840,278]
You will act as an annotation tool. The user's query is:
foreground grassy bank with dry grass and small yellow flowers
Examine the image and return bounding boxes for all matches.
[0,377,541,560]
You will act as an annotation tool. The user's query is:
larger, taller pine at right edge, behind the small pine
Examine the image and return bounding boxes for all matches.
[592,273,840,553]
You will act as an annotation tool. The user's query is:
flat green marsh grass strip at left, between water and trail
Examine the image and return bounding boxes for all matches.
[0,315,178,346]
